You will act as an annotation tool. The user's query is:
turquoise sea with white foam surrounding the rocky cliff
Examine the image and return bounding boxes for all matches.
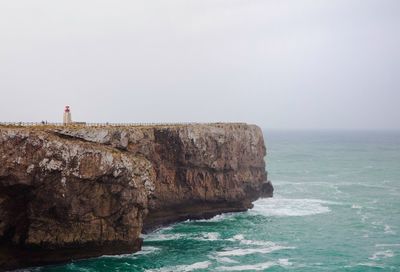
[28,131,400,272]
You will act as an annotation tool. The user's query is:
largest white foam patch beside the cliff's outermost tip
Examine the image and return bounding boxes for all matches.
[249,198,339,217]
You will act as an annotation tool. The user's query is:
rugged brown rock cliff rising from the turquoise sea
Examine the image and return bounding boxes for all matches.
[0,124,273,270]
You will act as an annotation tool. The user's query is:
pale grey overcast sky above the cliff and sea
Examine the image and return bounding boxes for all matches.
[0,0,400,129]
